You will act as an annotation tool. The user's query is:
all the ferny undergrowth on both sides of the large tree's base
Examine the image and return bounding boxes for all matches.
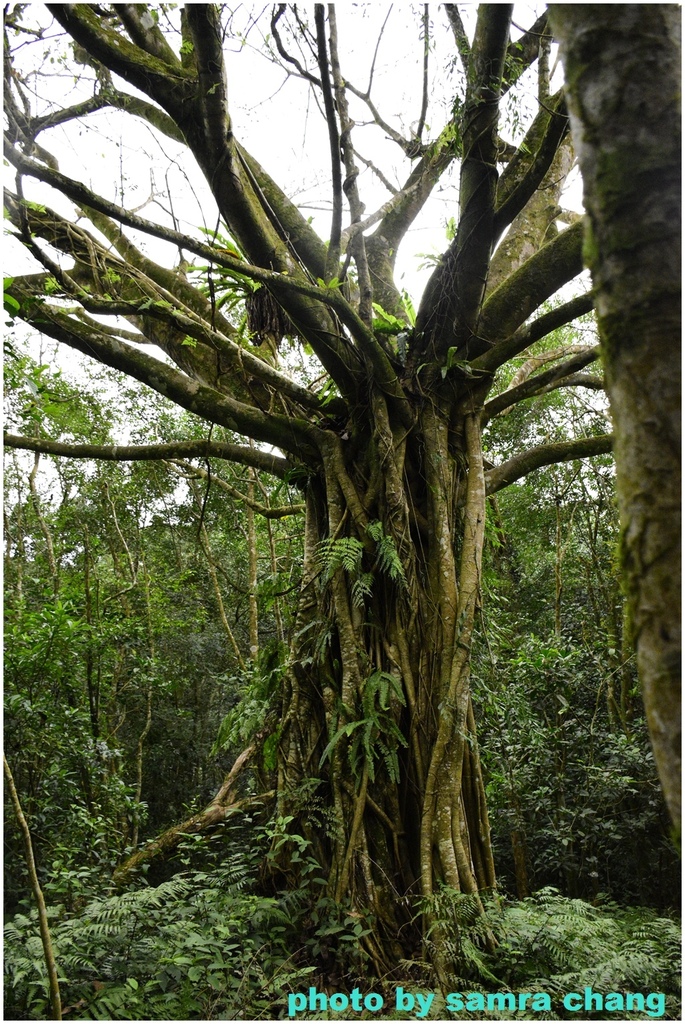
[4,829,681,1020]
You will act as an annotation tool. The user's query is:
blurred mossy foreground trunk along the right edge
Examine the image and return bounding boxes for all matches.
[551,4,681,825]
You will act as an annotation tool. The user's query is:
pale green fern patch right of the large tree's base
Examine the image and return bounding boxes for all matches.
[421,886,680,1020]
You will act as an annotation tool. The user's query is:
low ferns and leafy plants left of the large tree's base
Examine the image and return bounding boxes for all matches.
[4,830,307,1020]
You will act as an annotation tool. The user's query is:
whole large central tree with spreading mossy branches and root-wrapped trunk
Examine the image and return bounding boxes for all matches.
[5,4,626,971]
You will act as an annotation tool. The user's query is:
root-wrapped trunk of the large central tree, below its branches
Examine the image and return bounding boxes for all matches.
[279,400,496,970]
